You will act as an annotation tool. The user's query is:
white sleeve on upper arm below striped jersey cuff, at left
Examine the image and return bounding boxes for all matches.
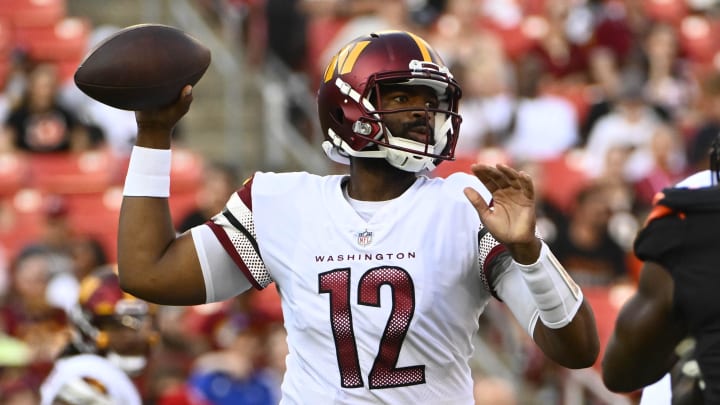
[190,225,252,303]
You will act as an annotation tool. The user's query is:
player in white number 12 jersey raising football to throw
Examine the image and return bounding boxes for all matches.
[119,31,599,405]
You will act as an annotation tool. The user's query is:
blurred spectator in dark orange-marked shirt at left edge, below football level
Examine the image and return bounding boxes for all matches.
[4,64,90,153]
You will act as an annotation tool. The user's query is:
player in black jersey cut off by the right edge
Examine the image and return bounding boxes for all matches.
[602,140,720,404]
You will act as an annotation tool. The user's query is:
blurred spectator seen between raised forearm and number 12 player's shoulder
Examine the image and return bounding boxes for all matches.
[178,162,239,232]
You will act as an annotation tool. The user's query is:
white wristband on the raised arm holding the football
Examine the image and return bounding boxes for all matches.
[123,146,172,198]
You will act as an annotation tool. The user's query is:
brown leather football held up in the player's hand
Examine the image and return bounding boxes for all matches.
[74,24,210,111]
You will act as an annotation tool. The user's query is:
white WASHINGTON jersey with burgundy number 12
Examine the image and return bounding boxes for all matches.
[201,173,511,405]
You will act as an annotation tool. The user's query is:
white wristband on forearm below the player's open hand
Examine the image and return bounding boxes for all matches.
[516,242,583,329]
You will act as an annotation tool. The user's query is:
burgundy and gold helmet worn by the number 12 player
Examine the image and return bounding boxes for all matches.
[317,31,461,172]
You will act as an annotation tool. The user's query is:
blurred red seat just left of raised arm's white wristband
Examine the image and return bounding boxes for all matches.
[28,150,117,194]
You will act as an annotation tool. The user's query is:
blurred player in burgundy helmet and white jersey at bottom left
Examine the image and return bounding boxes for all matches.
[40,266,156,405]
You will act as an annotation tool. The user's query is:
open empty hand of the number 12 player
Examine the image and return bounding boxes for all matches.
[465,164,536,249]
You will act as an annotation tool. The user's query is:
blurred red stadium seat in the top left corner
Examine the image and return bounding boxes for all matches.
[0,0,67,27]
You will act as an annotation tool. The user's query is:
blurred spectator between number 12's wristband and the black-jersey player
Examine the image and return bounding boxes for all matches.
[550,183,629,287]
